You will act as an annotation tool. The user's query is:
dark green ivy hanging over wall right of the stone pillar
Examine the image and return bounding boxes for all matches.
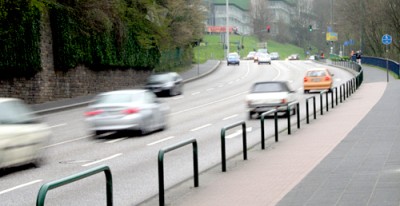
[50,1,160,70]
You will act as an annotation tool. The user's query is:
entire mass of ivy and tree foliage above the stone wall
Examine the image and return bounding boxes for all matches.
[0,0,203,78]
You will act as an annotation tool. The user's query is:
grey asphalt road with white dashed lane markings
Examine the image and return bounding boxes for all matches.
[0,61,352,205]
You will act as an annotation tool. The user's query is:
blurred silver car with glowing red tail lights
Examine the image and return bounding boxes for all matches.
[85,89,169,136]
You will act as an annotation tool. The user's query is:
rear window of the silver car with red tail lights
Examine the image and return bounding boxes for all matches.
[94,93,143,104]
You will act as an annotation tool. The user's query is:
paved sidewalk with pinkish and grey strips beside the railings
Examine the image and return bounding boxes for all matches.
[143,67,400,206]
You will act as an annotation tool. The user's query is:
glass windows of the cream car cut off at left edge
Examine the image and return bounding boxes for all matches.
[0,101,36,125]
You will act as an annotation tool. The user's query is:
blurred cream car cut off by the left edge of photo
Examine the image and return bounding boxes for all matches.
[0,98,51,168]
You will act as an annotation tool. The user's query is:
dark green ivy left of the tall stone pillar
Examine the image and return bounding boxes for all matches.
[0,1,41,79]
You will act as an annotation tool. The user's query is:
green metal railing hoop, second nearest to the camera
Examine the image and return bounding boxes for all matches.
[158,139,199,206]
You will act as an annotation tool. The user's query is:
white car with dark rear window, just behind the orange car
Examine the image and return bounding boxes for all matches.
[246,81,297,119]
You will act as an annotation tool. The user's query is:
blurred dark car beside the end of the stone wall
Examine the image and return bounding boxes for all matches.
[144,72,183,96]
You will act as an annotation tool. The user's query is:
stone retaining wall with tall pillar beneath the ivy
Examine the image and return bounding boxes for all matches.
[0,8,150,104]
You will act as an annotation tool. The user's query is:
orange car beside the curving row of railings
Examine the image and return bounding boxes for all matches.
[303,68,333,93]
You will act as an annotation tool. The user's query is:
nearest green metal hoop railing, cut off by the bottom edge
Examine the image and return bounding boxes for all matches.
[36,165,113,206]
